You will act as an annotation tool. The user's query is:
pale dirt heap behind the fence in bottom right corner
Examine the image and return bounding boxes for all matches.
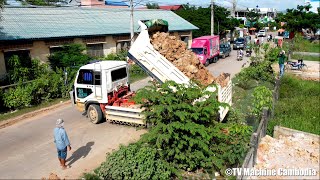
[250,133,320,179]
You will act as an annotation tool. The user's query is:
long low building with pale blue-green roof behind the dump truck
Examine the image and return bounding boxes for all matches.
[0,7,198,78]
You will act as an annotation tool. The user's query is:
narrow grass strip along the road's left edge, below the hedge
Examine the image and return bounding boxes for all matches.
[0,98,67,121]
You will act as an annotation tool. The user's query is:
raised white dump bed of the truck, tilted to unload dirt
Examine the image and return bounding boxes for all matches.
[128,21,232,121]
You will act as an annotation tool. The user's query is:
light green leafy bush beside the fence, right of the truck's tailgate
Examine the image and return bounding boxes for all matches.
[252,86,273,117]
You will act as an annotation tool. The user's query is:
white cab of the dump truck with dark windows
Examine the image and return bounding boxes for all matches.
[74,61,130,123]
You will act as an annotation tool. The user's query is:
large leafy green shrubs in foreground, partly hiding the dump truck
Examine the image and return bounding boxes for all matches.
[86,82,252,179]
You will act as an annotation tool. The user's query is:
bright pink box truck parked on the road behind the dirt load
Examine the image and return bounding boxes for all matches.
[191,36,220,66]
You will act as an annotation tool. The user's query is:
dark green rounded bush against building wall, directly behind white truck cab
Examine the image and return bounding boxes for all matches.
[48,44,91,69]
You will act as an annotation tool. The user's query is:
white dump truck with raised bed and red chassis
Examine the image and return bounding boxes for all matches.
[70,20,232,125]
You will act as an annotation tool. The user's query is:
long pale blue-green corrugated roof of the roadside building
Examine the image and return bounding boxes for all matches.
[0,7,198,41]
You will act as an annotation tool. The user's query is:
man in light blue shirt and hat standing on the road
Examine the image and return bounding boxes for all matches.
[53,119,71,169]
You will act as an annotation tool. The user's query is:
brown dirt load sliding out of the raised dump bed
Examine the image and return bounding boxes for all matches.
[151,32,227,87]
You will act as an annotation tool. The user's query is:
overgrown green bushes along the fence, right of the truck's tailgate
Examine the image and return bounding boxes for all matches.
[227,44,280,130]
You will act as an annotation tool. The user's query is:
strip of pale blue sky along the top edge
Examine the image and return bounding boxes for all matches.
[154,0,304,11]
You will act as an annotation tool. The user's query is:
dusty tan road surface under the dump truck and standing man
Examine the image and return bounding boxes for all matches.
[0,48,247,179]
